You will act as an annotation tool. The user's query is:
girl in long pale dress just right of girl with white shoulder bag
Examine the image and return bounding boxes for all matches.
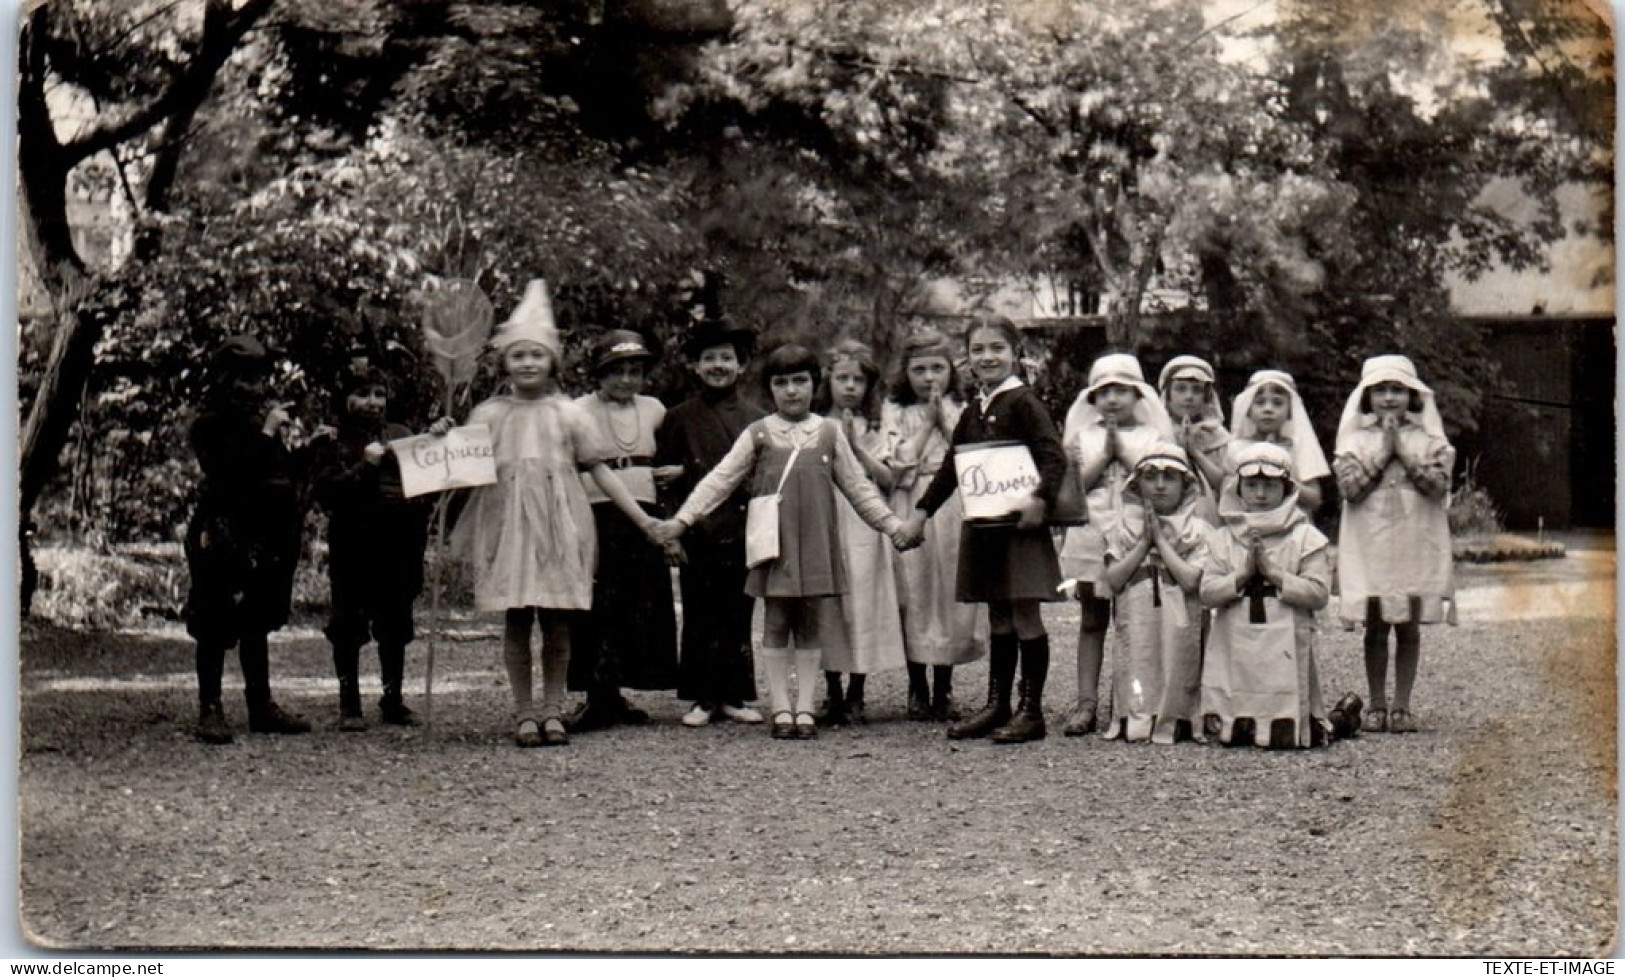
[819,340,904,727]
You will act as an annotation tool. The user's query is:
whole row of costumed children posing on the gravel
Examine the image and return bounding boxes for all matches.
[187,281,1454,748]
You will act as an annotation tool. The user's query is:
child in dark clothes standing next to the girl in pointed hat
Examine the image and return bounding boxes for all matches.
[312,366,452,732]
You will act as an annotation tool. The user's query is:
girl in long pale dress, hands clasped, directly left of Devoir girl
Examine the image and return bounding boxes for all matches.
[881,328,988,722]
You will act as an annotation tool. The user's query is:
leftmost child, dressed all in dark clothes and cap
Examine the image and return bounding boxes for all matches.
[185,335,310,745]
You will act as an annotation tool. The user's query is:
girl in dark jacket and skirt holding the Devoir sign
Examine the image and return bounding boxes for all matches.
[905,315,1066,743]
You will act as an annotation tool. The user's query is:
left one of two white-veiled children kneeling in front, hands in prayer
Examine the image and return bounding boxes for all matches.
[1102,442,1209,743]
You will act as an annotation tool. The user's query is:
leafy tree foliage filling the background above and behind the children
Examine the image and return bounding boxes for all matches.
[20,0,1612,552]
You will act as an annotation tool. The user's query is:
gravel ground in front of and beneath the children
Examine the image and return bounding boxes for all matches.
[18,554,1619,956]
